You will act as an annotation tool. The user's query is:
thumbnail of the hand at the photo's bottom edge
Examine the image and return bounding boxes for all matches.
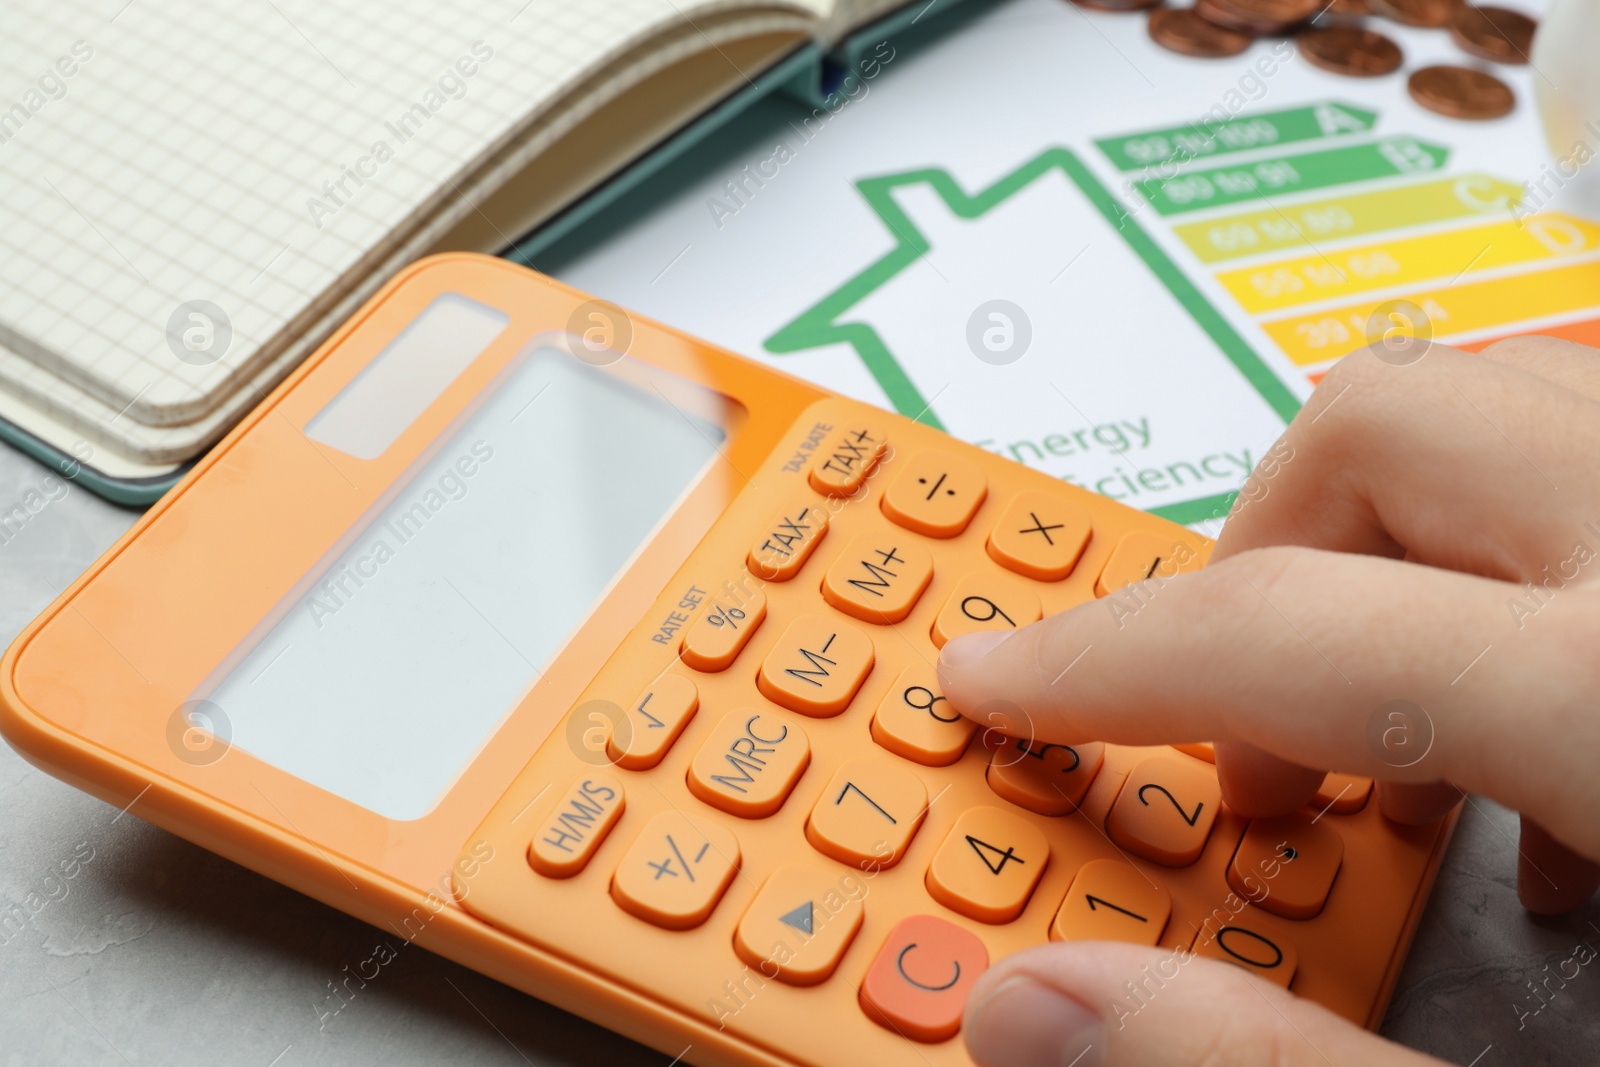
[966,974,1106,1067]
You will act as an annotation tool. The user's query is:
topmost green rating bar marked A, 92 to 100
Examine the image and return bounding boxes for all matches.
[1094,102,1378,171]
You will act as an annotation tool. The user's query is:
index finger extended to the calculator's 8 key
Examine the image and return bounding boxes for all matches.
[939,549,1600,857]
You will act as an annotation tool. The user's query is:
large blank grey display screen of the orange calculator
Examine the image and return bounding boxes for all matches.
[197,344,731,819]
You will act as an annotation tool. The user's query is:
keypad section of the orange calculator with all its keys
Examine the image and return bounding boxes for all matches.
[458,402,1459,1067]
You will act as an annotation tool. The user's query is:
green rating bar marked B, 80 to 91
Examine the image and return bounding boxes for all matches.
[1134,138,1450,214]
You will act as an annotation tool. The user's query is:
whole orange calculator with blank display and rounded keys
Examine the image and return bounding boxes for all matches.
[0,254,1451,1067]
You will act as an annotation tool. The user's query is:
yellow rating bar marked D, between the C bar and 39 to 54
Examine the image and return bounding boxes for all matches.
[1216,214,1600,315]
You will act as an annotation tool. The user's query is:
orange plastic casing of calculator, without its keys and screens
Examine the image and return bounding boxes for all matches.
[0,254,1450,1067]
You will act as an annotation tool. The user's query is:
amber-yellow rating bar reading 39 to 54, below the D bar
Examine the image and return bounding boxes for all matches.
[1262,259,1600,366]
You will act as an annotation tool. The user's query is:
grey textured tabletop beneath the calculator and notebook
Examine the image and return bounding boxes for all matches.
[0,425,1600,1067]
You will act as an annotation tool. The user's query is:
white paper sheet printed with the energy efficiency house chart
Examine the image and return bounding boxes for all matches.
[557,0,1600,533]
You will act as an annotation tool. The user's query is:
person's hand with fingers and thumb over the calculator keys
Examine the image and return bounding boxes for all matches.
[939,338,1600,1067]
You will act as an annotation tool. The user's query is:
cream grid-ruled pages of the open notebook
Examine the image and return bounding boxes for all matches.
[0,0,904,492]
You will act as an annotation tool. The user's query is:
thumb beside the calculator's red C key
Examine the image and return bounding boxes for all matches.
[963,941,1443,1067]
